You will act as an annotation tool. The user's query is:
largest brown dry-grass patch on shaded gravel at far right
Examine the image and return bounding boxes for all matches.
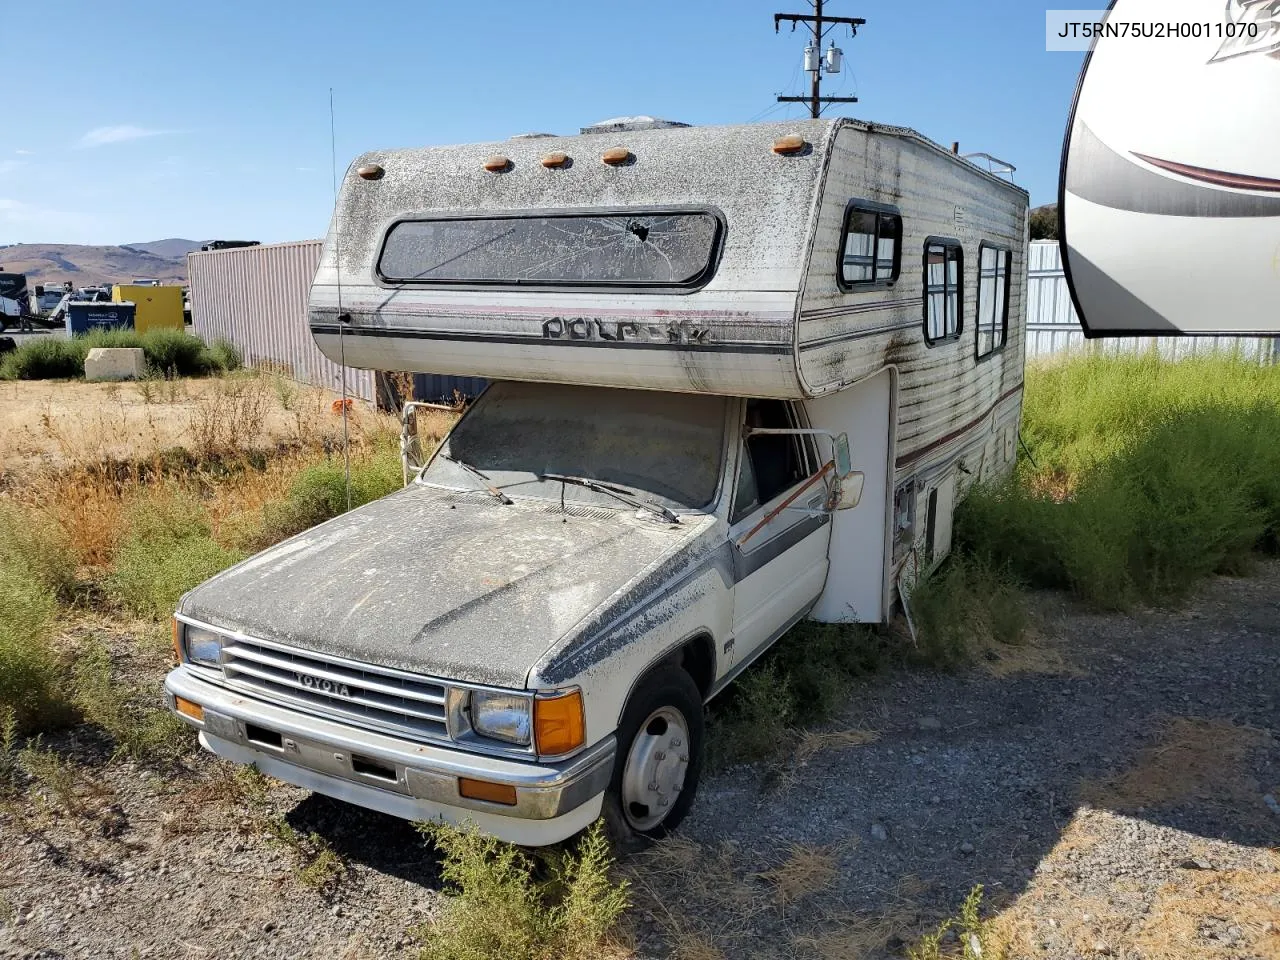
[1082,717,1268,817]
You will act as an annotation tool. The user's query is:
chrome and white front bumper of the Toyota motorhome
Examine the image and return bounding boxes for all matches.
[164,667,614,846]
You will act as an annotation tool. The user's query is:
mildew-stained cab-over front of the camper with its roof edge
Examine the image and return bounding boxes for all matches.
[310,118,1025,396]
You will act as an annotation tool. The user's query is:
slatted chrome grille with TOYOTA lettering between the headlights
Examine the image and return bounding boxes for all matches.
[223,637,448,740]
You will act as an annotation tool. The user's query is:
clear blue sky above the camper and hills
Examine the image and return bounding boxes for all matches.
[0,0,1083,243]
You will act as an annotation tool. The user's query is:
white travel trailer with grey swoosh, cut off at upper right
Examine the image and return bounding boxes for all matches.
[1059,0,1280,337]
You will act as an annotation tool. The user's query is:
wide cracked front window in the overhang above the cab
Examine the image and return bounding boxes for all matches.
[378,211,722,288]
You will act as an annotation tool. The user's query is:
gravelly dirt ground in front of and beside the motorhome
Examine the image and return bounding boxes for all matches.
[0,562,1280,960]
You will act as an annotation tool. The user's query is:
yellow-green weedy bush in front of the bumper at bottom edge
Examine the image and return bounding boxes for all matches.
[417,822,630,960]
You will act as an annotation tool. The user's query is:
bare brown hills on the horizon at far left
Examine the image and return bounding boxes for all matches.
[0,239,192,287]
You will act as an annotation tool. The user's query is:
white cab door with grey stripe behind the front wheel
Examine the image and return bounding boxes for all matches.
[730,399,831,662]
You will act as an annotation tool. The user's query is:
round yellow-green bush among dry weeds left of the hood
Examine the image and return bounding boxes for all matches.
[109,490,243,620]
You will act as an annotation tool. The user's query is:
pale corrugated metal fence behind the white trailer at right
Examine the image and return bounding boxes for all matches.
[1027,241,1280,364]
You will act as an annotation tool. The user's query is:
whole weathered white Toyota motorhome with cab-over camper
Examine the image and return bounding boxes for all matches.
[166,120,1028,845]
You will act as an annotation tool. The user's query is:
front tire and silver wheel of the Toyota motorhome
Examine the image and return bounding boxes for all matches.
[604,666,704,850]
